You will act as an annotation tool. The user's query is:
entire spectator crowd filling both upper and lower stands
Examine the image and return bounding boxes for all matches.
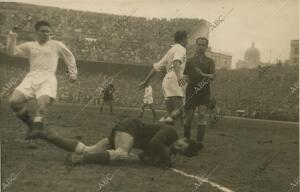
[0,3,299,120]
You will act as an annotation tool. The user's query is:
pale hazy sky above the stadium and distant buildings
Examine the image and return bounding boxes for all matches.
[4,0,299,67]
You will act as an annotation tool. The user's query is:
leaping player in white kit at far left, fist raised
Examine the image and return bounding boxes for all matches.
[7,21,77,139]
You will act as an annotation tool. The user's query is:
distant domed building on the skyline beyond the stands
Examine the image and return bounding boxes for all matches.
[236,43,261,69]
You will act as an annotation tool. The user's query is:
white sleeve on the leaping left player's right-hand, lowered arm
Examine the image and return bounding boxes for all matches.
[57,42,78,79]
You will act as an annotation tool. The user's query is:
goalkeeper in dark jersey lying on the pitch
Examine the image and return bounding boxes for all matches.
[34,119,201,167]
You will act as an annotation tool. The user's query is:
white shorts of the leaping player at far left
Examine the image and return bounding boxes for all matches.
[16,71,57,99]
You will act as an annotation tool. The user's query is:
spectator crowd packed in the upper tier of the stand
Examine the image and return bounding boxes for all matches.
[0,3,201,64]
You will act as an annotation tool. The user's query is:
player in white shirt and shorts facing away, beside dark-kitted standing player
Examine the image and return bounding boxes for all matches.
[139,31,187,123]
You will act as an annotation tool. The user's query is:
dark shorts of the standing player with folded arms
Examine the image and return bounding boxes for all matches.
[184,85,210,110]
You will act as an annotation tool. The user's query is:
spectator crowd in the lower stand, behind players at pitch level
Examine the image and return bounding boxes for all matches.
[0,65,299,121]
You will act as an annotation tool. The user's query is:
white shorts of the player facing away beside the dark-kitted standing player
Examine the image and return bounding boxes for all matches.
[162,75,184,99]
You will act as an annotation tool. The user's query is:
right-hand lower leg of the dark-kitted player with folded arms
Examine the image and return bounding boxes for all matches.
[197,105,207,143]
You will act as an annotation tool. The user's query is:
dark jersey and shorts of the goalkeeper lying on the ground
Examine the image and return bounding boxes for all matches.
[109,119,178,164]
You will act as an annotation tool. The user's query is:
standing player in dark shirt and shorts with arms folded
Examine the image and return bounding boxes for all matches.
[184,37,215,146]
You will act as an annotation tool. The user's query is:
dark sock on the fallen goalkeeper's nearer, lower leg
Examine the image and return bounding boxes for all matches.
[82,151,110,164]
